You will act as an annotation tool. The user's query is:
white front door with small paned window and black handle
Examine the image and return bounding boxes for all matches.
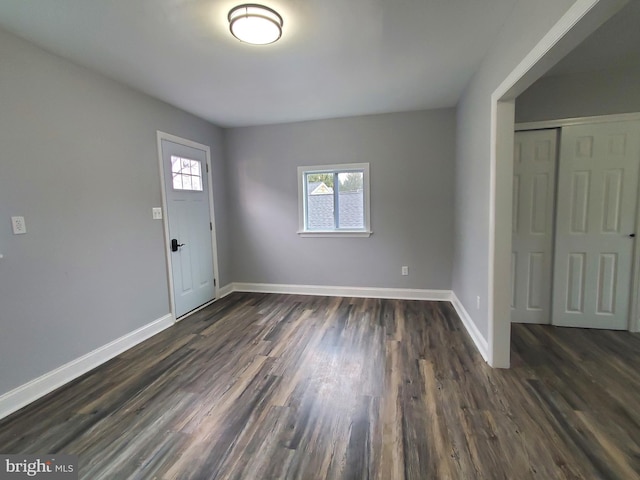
[161,139,215,318]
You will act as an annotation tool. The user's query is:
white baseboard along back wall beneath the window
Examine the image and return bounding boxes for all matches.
[232,283,451,301]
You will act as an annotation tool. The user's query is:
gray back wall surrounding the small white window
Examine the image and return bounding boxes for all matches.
[225,109,455,289]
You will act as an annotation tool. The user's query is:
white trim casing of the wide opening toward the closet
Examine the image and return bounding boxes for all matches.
[488,0,626,368]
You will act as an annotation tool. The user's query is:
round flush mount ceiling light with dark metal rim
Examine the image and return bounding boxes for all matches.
[228,3,283,45]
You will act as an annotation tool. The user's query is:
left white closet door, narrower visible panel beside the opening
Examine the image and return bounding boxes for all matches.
[511,130,557,323]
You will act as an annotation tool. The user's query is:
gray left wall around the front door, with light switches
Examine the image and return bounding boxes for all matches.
[0,31,230,394]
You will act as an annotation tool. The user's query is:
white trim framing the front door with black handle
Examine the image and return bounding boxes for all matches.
[156,130,220,323]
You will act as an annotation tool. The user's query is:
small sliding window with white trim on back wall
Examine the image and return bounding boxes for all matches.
[298,163,371,236]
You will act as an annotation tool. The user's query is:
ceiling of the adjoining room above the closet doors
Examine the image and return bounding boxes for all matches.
[546,0,640,76]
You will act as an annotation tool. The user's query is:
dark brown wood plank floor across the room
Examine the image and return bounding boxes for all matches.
[0,293,640,480]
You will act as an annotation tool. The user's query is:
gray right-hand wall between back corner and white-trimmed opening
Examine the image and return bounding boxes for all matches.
[452,0,574,338]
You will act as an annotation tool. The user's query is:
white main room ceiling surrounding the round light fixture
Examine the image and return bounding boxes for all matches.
[0,0,517,126]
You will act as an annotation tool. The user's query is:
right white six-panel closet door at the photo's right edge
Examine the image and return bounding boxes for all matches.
[552,122,640,330]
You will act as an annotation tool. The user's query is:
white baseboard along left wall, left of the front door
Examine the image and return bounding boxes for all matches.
[0,314,175,418]
